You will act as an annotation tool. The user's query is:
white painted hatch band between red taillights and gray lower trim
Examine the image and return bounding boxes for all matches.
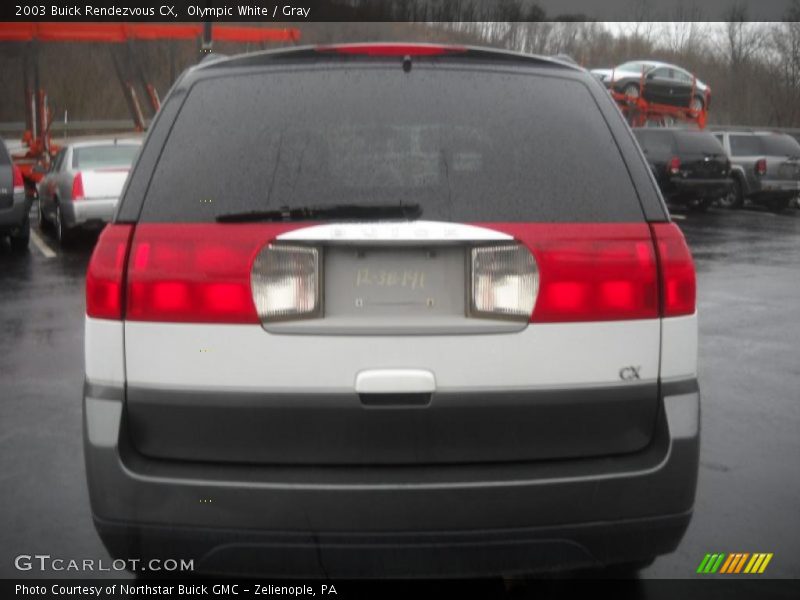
[125,319,661,392]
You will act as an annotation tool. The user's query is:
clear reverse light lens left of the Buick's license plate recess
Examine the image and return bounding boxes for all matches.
[252,244,320,322]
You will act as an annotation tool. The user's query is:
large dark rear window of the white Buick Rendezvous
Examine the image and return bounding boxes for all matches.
[141,67,643,222]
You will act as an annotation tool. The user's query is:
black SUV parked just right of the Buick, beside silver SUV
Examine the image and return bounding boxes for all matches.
[633,128,732,210]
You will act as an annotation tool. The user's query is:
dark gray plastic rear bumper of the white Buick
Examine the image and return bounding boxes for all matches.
[84,380,700,577]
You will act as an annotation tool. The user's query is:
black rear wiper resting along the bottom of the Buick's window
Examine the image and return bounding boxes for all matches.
[216,204,422,223]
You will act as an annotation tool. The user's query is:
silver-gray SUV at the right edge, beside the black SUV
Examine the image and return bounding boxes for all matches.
[714,131,800,211]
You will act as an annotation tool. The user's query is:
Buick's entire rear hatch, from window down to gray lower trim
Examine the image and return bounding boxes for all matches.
[101,51,694,465]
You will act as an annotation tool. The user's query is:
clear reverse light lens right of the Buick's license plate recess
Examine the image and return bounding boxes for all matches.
[470,244,539,321]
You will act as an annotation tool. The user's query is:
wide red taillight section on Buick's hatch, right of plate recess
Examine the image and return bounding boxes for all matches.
[485,223,659,323]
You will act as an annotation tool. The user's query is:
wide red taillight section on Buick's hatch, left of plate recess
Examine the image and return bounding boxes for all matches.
[125,223,297,323]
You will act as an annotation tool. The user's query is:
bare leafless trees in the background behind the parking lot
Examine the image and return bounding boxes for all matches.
[0,0,800,127]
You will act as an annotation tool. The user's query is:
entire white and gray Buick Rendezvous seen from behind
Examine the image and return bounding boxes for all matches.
[84,45,699,576]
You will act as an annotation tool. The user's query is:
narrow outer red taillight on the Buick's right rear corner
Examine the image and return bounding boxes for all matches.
[651,223,697,317]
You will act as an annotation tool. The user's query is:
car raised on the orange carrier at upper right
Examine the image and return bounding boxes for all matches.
[591,60,711,111]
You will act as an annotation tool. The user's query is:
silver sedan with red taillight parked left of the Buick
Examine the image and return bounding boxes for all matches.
[38,140,141,243]
